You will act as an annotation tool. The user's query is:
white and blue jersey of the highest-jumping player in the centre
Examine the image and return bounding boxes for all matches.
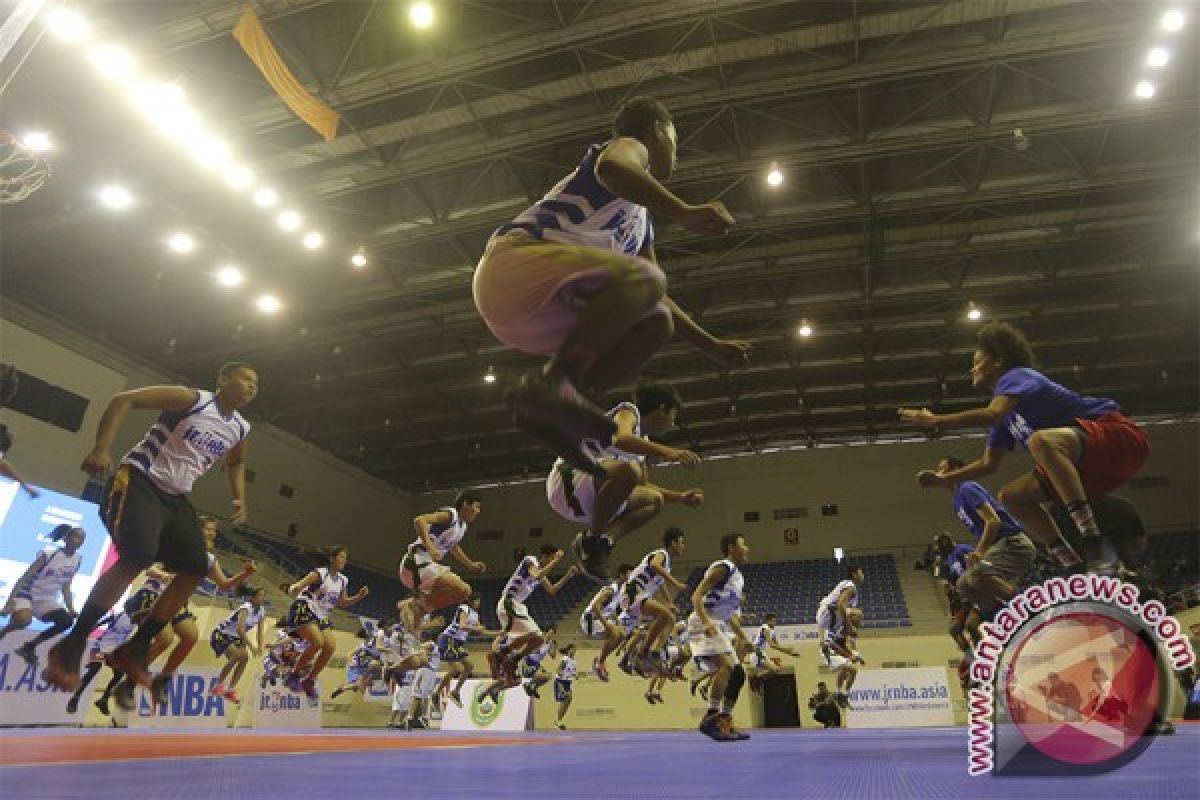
[496,142,654,255]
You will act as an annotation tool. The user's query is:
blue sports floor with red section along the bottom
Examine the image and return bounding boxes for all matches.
[0,724,1200,800]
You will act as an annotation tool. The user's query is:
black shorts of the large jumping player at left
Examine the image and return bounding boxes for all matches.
[101,464,209,577]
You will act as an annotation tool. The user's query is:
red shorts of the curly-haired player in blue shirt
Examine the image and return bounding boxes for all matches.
[1036,411,1150,501]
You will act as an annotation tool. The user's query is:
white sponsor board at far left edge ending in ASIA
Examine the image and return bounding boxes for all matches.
[0,631,94,726]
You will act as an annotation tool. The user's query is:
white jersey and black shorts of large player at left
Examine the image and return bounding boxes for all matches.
[101,390,250,575]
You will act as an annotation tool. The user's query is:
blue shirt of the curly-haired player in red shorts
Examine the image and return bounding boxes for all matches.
[988,367,1120,450]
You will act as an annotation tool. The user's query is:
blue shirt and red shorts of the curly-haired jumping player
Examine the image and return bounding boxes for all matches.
[988,367,1150,501]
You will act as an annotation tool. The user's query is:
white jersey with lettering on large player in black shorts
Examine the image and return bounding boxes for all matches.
[121,389,250,494]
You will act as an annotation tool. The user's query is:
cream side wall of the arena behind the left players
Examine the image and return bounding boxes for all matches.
[0,302,413,571]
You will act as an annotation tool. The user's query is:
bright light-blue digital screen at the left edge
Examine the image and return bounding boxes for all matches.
[0,477,115,631]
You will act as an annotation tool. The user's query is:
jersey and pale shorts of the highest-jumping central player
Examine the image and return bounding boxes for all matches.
[472,143,667,355]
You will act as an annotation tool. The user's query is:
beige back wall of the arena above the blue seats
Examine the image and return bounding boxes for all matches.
[413,422,1200,571]
